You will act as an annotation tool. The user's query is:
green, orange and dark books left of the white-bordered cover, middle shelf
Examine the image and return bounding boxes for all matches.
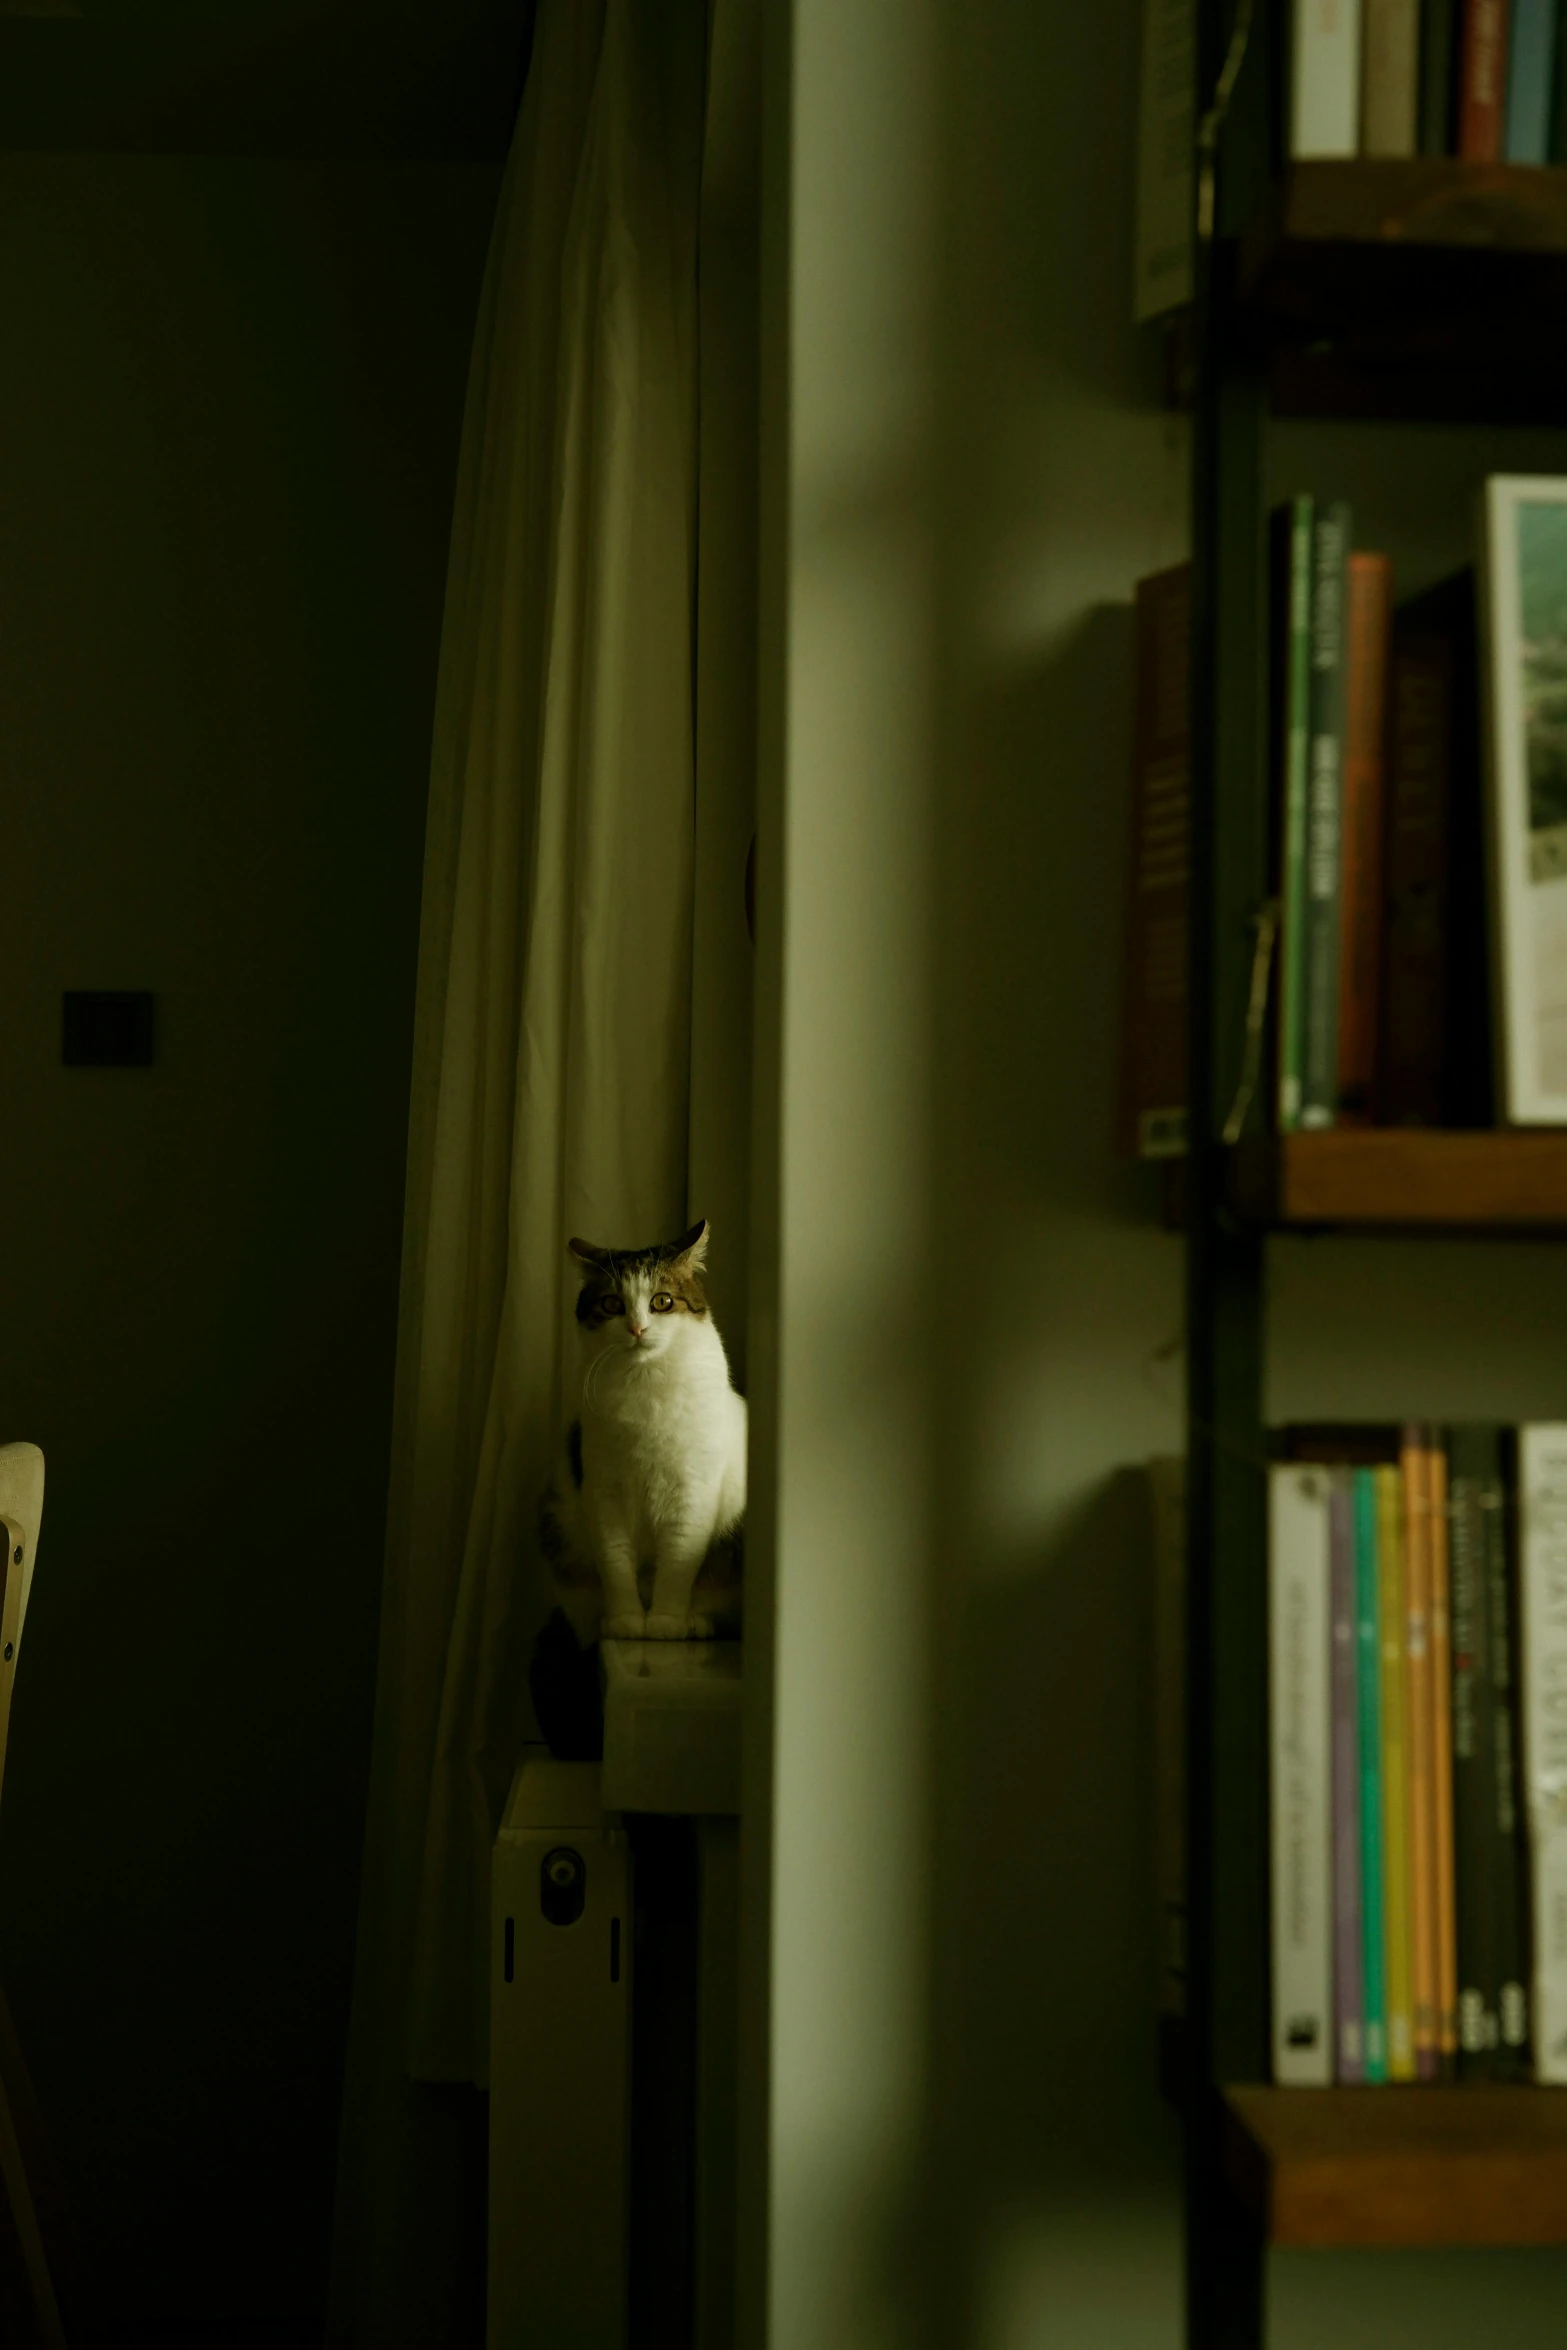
[1271,496,1492,1133]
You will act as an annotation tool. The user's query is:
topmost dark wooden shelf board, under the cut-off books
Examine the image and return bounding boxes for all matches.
[1240,157,1567,423]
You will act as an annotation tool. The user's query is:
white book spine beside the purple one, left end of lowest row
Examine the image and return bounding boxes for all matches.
[1269,1466,1332,2087]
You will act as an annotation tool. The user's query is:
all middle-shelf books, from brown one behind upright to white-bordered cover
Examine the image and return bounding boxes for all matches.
[1116,475,1567,1159]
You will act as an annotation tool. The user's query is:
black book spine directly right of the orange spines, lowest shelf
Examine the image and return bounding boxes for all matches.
[1447,1429,1497,2080]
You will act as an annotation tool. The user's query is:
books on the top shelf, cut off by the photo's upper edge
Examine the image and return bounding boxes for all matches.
[1290,0,1567,165]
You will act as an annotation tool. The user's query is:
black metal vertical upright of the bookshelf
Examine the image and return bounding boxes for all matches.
[1184,0,1269,2350]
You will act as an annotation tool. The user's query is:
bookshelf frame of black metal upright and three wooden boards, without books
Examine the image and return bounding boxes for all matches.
[1182,18,1567,2350]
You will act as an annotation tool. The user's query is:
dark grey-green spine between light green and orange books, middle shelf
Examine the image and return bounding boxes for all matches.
[1302,501,1351,1126]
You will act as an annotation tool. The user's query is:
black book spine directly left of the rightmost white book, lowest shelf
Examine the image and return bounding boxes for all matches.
[1480,1431,1529,2080]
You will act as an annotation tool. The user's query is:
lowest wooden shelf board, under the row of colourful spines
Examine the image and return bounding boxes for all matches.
[1224,2084,1567,2247]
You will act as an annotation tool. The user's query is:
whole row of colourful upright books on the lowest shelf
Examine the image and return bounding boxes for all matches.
[1269,1424,1567,2084]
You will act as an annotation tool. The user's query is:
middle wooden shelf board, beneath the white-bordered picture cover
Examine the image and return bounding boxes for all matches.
[1229,1126,1567,1234]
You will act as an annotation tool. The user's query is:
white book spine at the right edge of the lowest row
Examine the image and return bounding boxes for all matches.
[1518,1426,1567,2082]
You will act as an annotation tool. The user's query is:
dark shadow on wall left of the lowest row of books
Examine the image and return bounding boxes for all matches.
[951,1469,1177,2202]
